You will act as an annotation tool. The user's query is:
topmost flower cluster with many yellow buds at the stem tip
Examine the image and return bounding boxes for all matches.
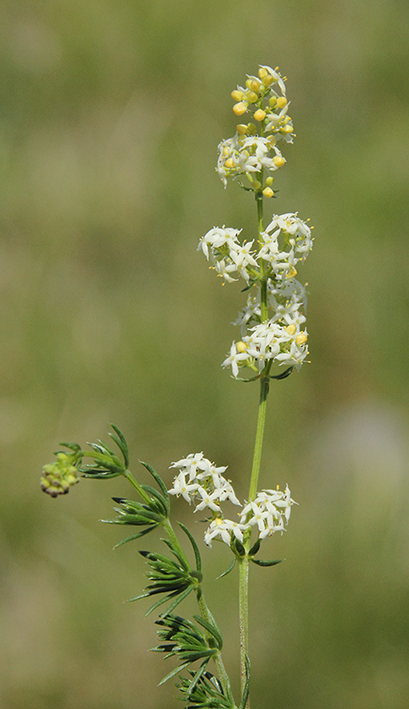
[217,66,294,189]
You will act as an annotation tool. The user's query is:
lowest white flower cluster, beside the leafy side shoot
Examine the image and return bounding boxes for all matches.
[169,453,297,547]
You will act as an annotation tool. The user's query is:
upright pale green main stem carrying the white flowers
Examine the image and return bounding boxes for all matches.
[239,189,271,709]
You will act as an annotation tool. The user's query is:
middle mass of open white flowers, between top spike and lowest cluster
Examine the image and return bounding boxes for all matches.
[198,213,313,377]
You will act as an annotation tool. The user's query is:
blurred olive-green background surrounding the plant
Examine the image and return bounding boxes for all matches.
[0,0,409,709]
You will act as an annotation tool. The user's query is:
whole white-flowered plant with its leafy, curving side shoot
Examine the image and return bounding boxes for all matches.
[41,66,313,709]
